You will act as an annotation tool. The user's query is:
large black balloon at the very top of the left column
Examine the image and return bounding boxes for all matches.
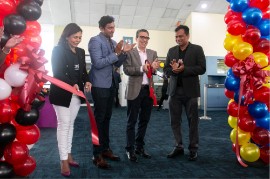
[17,1,41,21]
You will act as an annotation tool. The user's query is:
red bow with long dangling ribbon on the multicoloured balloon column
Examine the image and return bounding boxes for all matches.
[232,57,270,167]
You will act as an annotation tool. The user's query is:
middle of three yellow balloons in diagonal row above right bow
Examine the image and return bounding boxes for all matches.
[232,42,253,60]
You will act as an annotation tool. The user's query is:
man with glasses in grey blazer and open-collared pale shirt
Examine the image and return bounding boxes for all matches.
[123,29,159,162]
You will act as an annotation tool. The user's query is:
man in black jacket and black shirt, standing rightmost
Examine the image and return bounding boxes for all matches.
[164,25,206,161]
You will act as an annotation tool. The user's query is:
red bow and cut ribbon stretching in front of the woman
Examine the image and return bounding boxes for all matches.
[19,45,99,145]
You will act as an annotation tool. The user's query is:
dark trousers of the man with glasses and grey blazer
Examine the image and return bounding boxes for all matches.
[126,87,153,151]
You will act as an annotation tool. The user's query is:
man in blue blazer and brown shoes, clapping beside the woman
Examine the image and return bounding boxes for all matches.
[88,16,135,169]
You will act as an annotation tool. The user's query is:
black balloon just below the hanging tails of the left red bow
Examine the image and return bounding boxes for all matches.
[15,108,39,126]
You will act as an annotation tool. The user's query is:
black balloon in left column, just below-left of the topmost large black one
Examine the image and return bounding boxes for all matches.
[4,14,26,35]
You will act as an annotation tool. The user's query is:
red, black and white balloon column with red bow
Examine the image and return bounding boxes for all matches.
[0,0,47,178]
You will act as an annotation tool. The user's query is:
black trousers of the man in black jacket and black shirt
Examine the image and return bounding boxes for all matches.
[169,87,199,151]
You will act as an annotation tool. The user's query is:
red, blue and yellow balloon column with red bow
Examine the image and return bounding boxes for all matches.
[224,0,270,164]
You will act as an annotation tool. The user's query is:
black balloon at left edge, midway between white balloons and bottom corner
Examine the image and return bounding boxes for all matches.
[0,123,16,146]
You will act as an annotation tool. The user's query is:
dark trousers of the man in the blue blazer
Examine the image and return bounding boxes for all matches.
[92,87,115,156]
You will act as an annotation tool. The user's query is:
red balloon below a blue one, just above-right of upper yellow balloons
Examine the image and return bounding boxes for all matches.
[242,26,261,45]
